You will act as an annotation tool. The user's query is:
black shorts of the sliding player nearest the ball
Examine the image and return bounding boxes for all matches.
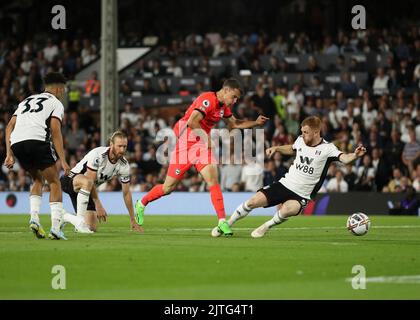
[258,181,309,213]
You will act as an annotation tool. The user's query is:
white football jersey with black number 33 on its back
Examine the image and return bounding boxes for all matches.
[10,92,64,145]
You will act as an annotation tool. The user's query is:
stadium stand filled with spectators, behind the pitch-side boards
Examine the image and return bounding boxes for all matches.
[0,10,420,192]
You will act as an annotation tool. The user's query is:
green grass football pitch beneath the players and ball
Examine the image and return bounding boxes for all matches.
[0,215,420,300]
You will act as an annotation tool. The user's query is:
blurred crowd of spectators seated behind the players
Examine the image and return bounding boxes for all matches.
[0,26,420,192]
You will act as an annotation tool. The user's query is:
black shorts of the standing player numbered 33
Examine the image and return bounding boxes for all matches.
[11,140,58,171]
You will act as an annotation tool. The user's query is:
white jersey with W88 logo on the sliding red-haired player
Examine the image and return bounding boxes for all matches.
[279,136,342,199]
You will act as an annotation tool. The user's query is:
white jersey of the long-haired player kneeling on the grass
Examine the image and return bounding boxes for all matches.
[69,147,130,186]
